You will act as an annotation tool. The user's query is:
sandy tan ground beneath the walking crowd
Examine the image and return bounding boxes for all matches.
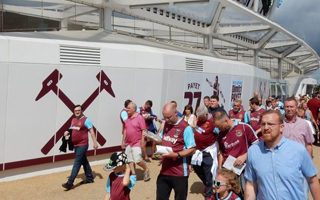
[0,146,320,200]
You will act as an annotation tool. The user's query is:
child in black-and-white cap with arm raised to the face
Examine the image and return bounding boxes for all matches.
[103,151,137,200]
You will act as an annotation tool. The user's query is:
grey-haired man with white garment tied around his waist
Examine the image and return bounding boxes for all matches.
[191,106,218,199]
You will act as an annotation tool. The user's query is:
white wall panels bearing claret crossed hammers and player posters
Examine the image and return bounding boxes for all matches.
[0,44,269,178]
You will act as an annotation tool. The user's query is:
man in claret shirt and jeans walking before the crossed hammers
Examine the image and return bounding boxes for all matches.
[62,105,98,190]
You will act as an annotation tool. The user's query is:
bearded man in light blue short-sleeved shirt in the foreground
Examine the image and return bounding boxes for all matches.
[245,110,320,200]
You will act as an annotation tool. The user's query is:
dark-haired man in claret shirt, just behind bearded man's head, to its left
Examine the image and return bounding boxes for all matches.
[244,97,265,140]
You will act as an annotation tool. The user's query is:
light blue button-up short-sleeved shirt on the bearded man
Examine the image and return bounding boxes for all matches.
[244,137,318,200]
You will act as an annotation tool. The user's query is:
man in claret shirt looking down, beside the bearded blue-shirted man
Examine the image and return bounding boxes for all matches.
[213,111,259,196]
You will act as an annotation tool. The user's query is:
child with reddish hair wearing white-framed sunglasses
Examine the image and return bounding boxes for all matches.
[211,169,241,200]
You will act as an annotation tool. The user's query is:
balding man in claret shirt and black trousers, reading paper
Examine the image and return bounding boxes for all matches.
[156,103,196,200]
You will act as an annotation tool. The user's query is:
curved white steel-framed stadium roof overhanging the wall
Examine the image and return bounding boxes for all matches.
[3,0,319,75]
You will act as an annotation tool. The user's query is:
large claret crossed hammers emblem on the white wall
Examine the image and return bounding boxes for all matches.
[36,69,115,155]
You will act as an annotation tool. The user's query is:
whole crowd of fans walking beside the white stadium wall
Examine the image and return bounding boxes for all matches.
[62,92,320,200]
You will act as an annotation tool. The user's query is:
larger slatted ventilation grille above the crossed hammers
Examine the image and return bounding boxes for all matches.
[60,46,101,65]
